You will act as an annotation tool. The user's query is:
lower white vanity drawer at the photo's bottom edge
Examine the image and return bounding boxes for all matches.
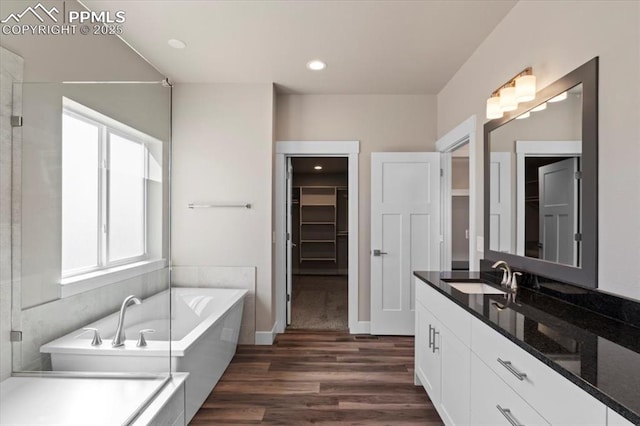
[470,354,549,426]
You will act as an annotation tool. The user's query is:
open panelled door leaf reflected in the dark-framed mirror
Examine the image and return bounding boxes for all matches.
[538,157,578,266]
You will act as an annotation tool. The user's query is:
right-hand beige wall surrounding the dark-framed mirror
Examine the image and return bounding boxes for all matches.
[437,1,640,300]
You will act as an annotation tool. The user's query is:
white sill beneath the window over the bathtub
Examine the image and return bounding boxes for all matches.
[60,259,167,299]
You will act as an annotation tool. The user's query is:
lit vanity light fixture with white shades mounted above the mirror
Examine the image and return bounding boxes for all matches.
[486,67,536,120]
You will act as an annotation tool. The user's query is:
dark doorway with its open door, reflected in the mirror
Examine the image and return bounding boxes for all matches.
[525,157,580,266]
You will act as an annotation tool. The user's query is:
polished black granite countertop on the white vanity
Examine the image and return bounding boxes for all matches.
[414,271,640,424]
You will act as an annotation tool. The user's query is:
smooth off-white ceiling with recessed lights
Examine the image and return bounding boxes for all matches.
[82,0,516,94]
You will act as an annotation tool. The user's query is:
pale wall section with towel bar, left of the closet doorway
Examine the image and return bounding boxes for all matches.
[171,84,274,331]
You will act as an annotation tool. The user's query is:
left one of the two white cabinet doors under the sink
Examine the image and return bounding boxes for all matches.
[415,302,441,407]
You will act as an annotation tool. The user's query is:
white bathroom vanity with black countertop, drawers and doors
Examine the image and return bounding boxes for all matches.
[414,271,640,425]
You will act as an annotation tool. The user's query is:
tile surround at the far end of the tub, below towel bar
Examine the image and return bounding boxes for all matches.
[171,266,256,345]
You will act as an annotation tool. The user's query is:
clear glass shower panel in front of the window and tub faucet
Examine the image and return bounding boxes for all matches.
[8,82,171,384]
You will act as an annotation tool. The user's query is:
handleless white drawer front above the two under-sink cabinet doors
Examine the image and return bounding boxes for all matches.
[415,278,471,347]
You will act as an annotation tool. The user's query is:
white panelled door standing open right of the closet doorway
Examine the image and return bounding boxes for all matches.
[371,152,441,335]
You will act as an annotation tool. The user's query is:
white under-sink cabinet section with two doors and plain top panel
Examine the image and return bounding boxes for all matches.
[415,282,471,425]
